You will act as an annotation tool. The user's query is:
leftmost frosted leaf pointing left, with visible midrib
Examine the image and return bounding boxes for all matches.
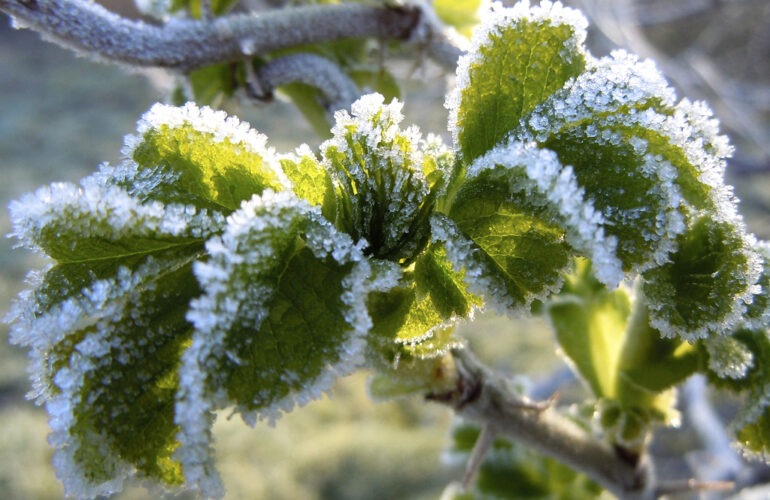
[8,171,224,376]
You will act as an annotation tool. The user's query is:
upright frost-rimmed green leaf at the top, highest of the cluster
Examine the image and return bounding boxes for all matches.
[446,1,587,163]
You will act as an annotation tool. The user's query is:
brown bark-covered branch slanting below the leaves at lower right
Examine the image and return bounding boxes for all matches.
[427,349,655,500]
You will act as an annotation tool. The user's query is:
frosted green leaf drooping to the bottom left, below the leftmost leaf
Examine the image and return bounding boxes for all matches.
[28,247,202,497]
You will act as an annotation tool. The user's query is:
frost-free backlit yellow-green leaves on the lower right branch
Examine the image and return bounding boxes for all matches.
[547,260,688,430]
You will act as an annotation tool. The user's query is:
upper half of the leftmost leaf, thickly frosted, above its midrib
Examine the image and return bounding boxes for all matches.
[9,175,219,264]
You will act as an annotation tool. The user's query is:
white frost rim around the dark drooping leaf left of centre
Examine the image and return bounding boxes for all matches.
[176,190,378,496]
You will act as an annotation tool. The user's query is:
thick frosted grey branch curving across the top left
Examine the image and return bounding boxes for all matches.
[0,0,421,71]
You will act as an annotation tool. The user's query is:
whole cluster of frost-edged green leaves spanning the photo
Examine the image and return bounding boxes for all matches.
[9,1,770,497]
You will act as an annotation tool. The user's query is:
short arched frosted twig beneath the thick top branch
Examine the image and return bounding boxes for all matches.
[256,54,360,111]
